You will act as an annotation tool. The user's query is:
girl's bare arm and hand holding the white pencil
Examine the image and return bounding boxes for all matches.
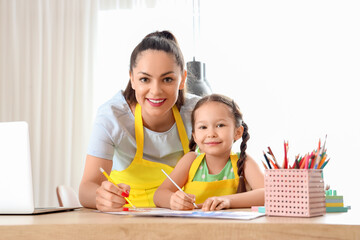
[154,152,196,210]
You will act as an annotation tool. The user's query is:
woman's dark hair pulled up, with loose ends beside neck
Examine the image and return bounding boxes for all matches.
[124,31,185,110]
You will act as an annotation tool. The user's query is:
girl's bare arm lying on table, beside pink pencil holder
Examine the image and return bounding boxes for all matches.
[202,156,265,211]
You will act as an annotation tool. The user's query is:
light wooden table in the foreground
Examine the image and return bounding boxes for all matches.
[0,208,360,240]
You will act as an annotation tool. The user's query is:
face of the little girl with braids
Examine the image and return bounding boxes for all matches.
[193,102,244,156]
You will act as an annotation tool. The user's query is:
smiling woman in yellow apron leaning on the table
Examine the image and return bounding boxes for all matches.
[79,31,199,211]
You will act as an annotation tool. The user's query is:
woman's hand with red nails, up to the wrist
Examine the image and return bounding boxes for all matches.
[96,181,130,212]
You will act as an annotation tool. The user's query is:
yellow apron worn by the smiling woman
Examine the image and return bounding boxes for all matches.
[110,104,189,207]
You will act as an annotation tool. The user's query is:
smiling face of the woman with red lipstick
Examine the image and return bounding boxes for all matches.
[130,50,186,117]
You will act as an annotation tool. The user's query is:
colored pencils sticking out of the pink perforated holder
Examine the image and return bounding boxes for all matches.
[262,136,330,169]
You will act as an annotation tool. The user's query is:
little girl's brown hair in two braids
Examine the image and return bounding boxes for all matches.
[189,94,250,192]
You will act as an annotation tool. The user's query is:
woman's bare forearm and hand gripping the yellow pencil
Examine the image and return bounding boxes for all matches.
[79,155,130,212]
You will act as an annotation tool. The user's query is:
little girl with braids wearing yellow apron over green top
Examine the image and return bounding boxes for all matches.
[154,94,264,211]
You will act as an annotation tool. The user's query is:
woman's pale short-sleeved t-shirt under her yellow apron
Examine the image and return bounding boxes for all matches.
[87,91,199,171]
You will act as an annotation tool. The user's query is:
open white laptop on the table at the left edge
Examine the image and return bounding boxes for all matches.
[0,122,79,214]
